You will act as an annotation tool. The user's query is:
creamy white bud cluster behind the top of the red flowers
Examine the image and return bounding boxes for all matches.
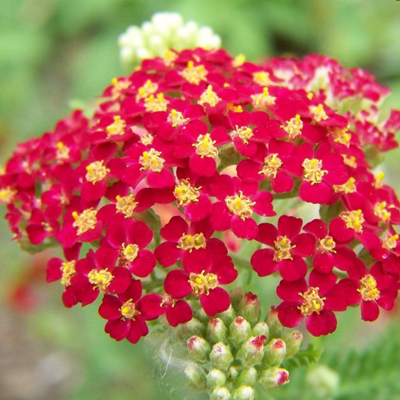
[118,12,221,69]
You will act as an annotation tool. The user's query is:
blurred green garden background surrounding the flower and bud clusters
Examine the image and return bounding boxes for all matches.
[0,0,400,400]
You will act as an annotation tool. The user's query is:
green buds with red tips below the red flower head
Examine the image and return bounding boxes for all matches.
[178,290,303,400]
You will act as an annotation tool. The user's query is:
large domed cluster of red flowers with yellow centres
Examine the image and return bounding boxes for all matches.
[0,49,400,343]
